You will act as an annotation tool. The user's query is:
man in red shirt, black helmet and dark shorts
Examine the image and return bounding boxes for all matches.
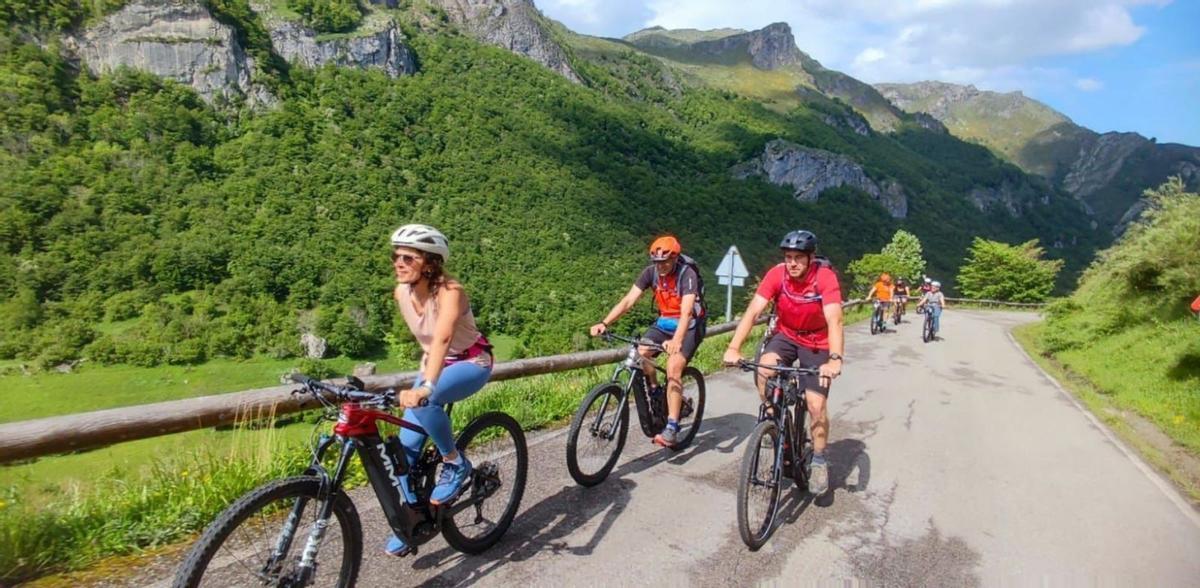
[725,230,845,496]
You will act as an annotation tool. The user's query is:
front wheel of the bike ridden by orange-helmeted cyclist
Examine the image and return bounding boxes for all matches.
[566,382,629,486]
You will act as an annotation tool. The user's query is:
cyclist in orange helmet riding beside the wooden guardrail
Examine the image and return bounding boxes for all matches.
[592,236,708,448]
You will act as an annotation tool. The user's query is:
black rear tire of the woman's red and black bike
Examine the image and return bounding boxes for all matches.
[442,412,529,554]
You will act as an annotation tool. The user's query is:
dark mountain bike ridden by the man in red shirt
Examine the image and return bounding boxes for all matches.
[738,361,820,551]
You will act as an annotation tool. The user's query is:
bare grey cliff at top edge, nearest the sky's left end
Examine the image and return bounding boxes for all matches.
[431,0,582,83]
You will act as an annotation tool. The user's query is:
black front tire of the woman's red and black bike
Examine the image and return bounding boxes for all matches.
[173,475,362,588]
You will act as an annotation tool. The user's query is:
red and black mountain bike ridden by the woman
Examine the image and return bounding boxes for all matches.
[174,374,529,588]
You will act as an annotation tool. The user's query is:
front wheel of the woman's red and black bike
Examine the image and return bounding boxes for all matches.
[174,476,362,588]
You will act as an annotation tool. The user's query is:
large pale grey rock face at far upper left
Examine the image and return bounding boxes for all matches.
[68,0,275,104]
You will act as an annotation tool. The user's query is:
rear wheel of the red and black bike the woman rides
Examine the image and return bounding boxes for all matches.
[442,413,529,554]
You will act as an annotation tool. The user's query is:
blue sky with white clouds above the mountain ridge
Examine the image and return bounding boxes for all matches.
[535,0,1200,145]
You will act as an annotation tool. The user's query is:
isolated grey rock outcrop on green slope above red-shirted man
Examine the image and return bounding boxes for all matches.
[732,139,908,218]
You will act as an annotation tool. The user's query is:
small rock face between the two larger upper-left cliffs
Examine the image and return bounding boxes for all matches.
[266,19,416,78]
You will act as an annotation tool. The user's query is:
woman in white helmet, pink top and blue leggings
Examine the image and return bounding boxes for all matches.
[386,224,492,556]
